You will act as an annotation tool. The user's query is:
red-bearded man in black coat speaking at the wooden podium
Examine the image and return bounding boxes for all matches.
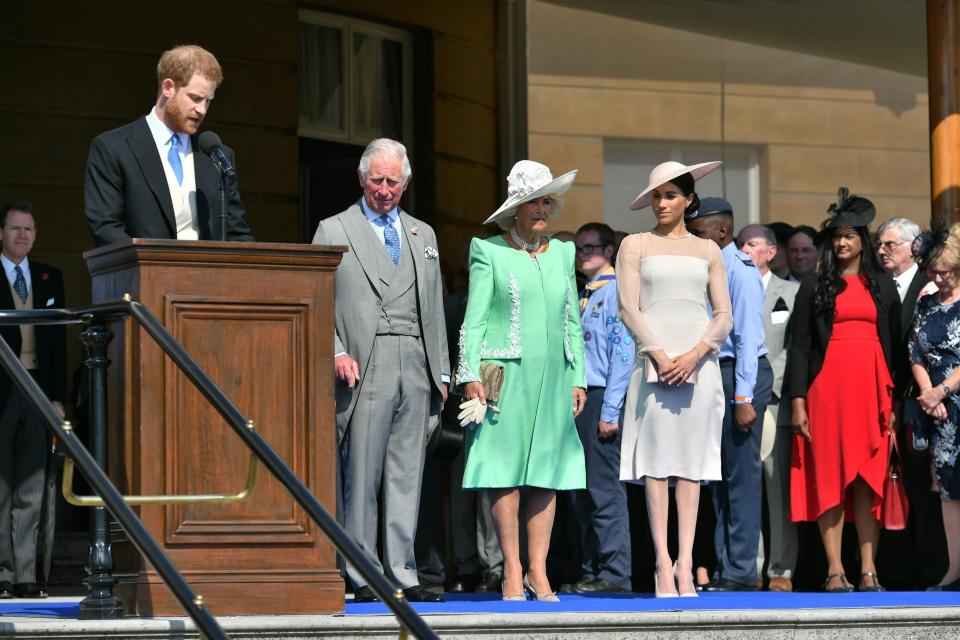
[83,45,253,247]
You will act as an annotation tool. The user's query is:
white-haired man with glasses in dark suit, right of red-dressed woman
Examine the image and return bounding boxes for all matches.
[877,218,946,589]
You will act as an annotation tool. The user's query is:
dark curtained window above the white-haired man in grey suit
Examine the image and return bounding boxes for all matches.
[298,11,413,148]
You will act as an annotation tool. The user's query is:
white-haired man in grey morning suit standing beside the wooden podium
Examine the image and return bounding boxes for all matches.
[313,138,450,602]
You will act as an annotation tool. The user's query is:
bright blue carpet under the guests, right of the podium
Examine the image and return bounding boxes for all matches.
[345,591,960,615]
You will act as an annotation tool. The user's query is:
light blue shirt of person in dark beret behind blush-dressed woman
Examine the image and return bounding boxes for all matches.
[720,242,767,404]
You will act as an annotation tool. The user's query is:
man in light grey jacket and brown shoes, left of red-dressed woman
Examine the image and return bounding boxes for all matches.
[737,224,800,591]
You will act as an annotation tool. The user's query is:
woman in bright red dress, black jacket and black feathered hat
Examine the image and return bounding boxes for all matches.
[789,188,902,592]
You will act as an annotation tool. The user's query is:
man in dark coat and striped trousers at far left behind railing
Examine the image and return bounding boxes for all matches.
[0,202,67,598]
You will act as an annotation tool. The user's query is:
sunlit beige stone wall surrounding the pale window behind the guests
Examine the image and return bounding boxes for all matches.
[529,2,930,235]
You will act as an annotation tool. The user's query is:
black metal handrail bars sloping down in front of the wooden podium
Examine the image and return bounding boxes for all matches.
[0,300,437,640]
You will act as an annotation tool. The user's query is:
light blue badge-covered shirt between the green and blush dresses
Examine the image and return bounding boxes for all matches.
[580,272,637,424]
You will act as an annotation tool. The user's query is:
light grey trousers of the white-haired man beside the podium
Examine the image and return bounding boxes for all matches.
[340,335,431,589]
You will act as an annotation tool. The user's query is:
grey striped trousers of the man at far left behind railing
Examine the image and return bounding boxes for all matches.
[0,385,48,584]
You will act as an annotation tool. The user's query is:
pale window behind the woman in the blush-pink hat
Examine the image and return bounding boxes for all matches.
[603,140,761,232]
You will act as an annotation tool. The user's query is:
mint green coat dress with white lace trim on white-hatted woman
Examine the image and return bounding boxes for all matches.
[456,236,586,490]
